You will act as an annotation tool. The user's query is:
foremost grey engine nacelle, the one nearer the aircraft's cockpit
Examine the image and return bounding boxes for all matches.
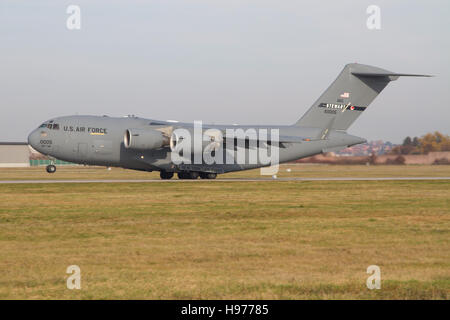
[123,129,168,150]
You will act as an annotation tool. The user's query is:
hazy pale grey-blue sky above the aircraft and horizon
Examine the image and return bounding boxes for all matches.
[0,0,450,142]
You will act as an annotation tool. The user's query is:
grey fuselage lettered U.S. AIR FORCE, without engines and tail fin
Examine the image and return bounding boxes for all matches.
[28,116,365,173]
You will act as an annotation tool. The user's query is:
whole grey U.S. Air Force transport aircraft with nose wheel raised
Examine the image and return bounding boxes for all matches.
[28,63,428,179]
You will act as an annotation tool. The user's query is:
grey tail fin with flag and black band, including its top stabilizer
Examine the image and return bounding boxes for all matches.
[295,63,429,131]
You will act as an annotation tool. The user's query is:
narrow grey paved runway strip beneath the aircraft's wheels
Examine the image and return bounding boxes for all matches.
[0,177,450,184]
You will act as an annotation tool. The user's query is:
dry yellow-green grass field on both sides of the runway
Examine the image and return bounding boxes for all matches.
[0,166,450,299]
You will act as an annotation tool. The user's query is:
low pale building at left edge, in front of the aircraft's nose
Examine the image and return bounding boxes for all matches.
[0,142,31,168]
